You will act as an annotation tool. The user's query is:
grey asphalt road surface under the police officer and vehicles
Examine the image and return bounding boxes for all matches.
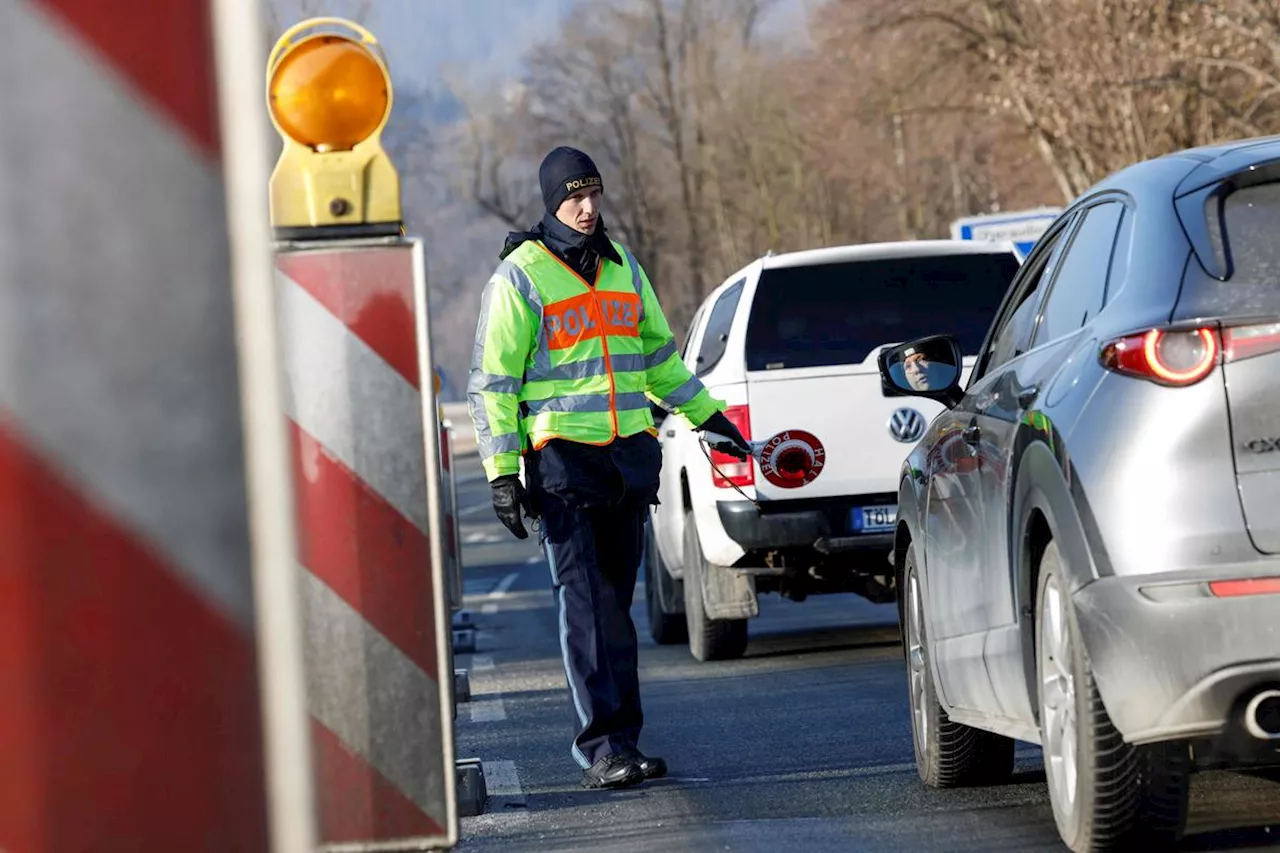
[445,448,1280,853]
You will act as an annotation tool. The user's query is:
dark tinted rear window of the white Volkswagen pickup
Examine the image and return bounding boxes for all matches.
[746,254,1018,370]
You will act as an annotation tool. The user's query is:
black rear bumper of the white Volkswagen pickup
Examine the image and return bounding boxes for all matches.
[716,500,893,553]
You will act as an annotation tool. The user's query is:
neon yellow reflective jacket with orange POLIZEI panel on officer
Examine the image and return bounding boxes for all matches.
[467,241,724,480]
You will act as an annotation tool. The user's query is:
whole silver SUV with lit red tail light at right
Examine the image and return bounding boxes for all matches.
[879,138,1280,850]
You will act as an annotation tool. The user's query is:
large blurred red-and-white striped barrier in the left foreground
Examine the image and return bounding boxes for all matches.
[0,0,312,853]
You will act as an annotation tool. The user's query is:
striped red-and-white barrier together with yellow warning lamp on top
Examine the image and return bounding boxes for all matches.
[266,18,483,835]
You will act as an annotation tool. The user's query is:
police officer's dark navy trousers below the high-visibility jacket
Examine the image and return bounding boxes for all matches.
[526,434,662,767]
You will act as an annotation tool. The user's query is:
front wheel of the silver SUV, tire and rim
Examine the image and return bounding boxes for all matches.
[899,544,1014,788]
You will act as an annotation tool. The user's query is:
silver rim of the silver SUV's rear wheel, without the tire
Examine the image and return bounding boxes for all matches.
[1039,578,1079,817]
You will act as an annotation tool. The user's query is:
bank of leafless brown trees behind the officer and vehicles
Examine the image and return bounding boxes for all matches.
[442,0,1280,350]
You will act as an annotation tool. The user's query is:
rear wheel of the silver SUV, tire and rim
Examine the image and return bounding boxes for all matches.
[1036,542,1192,853]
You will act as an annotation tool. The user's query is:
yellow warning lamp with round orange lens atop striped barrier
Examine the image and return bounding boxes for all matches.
[266,18,404,240]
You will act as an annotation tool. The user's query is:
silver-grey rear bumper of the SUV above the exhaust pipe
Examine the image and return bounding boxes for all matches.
[1074,575,1280,745]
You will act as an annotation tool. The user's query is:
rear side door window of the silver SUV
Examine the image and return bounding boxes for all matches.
[1032,201,1124,347]
